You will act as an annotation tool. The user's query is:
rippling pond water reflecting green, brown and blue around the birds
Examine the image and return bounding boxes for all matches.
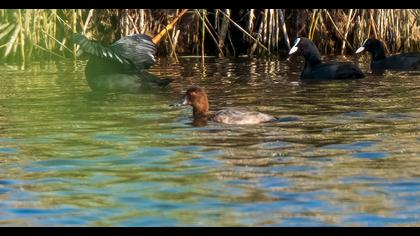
[0,55,420,226]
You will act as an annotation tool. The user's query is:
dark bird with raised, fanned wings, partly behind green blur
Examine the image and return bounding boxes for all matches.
[73,33,172,91]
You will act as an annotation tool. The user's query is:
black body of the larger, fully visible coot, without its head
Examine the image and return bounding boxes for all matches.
[301,62,364,79]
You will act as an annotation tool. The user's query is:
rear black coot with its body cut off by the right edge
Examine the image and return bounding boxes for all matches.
[356,39,420,72]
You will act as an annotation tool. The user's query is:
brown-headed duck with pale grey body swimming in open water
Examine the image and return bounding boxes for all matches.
[176,86,277,125]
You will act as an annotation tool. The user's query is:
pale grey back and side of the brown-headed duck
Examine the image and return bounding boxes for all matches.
[211,108,276,124]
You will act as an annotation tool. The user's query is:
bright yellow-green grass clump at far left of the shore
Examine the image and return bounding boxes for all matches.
[0,9,85,62]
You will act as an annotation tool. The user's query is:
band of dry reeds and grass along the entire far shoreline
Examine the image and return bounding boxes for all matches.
[0,9,420,64]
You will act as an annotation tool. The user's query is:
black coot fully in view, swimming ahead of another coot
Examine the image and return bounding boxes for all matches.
[289,37,364,79]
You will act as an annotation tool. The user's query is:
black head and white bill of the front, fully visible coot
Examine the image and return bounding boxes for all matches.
[289,37,321,64]
